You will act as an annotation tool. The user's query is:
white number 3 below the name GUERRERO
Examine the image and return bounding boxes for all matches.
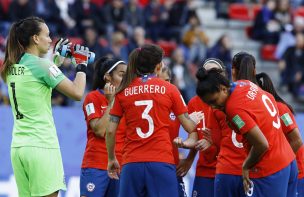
[134,100,154,138]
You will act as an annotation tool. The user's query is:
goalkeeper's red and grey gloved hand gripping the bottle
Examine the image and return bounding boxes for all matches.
[71,44,89,67]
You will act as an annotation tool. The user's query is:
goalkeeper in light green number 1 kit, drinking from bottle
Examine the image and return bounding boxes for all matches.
[0,17,89,197]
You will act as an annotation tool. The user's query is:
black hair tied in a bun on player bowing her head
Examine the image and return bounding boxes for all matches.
[196,67,230,101]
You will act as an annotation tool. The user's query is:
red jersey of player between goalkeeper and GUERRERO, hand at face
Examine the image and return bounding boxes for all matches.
[81,90,125,170]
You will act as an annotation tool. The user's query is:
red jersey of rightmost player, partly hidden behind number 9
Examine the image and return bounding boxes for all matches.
[277,102,304,179]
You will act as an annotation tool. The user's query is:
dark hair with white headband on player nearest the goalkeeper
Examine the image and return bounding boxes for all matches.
[93,56,125,90]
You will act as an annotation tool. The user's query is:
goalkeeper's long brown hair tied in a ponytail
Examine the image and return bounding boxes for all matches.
[1,17,45,80]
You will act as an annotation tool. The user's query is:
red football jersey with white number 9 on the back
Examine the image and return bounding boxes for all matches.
[225,80,295,178]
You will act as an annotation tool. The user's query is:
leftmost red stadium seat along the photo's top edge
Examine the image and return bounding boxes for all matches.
[228,3,252,21]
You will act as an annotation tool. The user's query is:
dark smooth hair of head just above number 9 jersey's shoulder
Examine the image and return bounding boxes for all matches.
[232,52,257,84]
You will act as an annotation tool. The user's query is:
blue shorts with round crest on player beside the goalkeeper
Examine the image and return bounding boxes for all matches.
[80,168,110,197]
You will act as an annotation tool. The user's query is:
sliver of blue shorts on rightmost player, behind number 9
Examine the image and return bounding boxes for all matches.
[287,160,298,197]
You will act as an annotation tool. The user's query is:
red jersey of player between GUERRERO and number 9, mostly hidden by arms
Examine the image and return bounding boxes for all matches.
[188,96,221,178]
